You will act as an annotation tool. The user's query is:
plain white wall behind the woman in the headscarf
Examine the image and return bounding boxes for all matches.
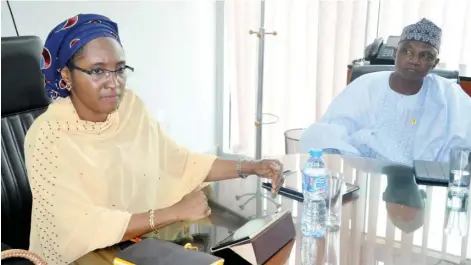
[2,0,221,152]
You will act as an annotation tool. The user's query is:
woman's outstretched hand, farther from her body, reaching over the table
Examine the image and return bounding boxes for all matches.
[254,159,285,193]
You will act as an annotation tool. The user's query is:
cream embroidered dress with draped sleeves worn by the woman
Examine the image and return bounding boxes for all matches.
[25,90,215,265]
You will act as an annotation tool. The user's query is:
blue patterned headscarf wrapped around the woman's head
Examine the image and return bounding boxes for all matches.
[41,14,121,99]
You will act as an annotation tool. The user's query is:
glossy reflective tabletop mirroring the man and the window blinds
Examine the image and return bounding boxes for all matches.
[180,155,471,265]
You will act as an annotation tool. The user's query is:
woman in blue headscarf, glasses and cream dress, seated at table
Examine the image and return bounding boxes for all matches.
[25,14,283,265]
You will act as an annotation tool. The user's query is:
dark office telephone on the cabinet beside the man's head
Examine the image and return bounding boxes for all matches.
[365,36,400,65]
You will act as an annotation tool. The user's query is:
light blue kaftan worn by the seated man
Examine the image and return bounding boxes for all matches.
[300,72,471,164]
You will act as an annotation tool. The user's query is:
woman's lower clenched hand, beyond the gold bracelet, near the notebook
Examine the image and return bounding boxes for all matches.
[171,188,211,221]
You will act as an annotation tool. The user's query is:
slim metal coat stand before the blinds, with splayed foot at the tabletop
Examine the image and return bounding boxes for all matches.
[235,0,281,216]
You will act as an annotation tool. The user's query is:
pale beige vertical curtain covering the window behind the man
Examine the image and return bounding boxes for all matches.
[224,0,471,156]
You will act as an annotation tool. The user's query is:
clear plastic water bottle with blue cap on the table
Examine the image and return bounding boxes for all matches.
[301,149,328,238]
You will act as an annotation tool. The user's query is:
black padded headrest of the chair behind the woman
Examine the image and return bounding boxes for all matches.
[2,36,51,117]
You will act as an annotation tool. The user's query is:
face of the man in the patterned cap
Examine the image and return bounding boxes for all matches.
[395,41,440,81]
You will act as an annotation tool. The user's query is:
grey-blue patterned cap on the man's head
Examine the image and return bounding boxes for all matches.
[401,18,442,50]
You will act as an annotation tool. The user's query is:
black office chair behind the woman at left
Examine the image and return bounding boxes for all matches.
[1,36,51,264]
